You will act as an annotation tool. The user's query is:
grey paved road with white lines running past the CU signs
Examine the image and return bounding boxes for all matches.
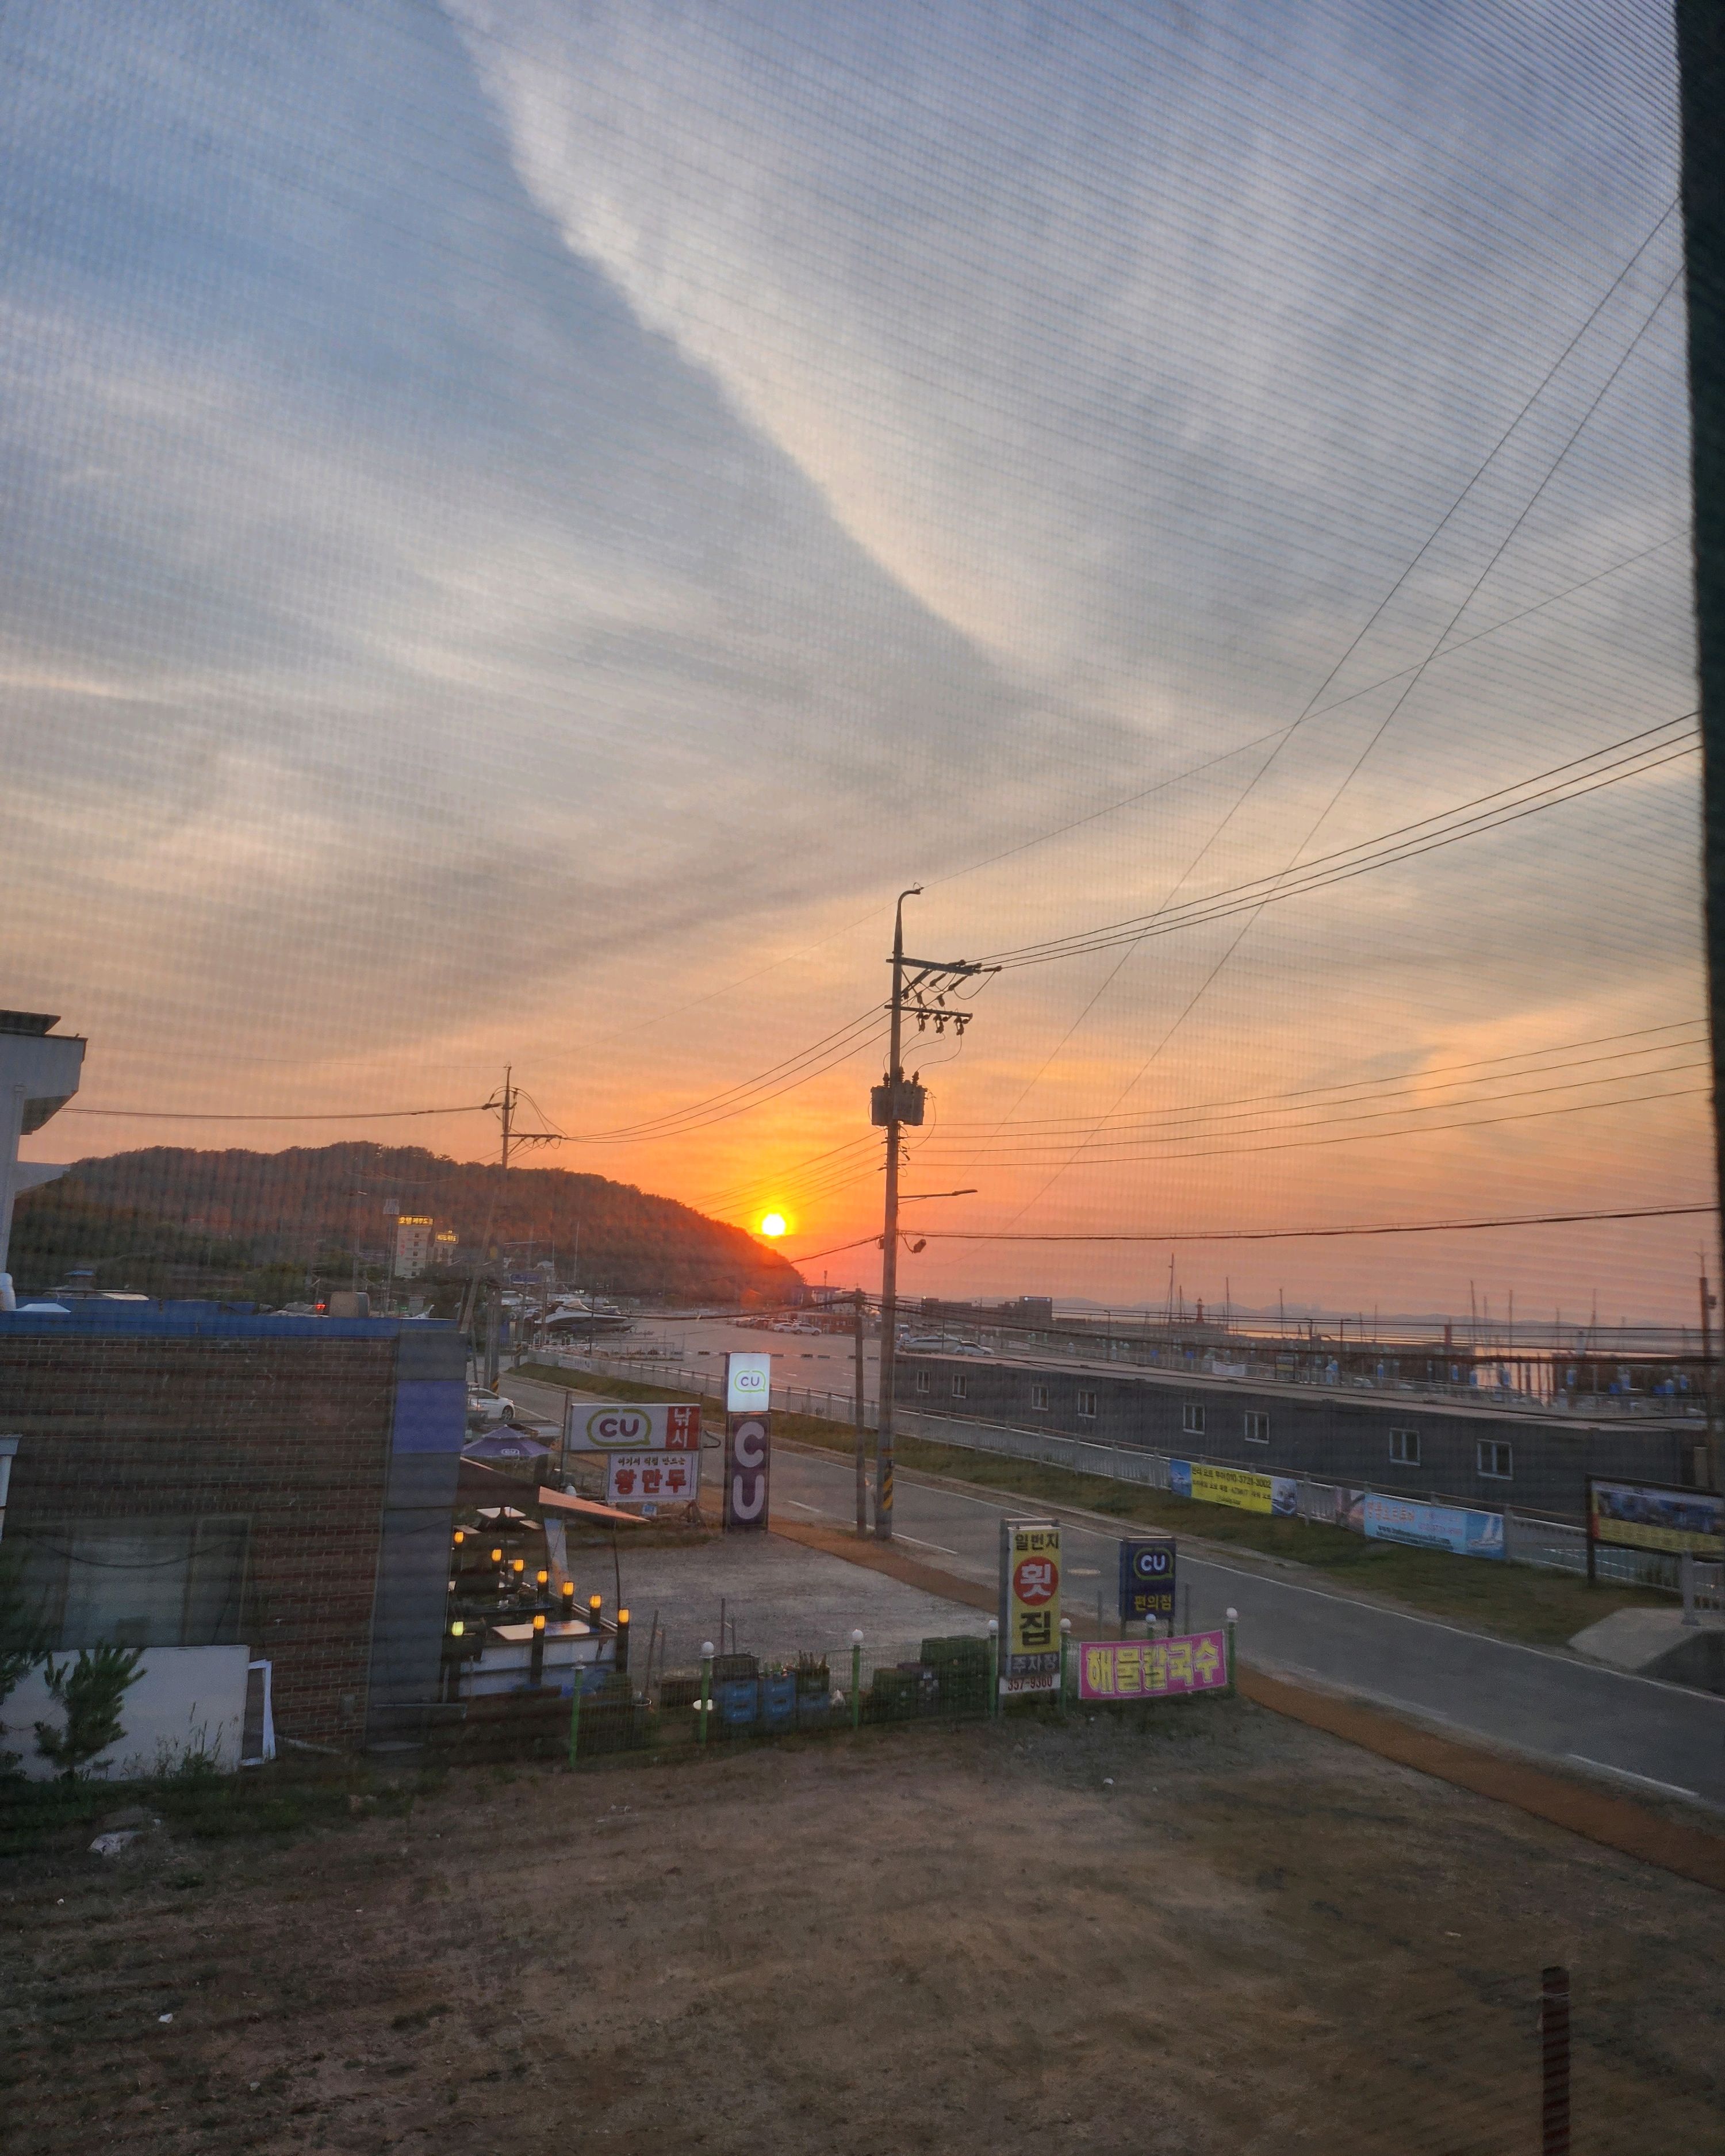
[772,1447,1725,1805]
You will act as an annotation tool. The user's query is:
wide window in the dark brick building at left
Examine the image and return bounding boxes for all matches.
[20,1514,250,1649]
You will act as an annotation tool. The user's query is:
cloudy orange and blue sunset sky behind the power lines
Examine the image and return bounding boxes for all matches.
[0,0,1712,1322]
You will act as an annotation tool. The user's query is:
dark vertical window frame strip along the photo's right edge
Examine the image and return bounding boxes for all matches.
[1676,0,1725,1490]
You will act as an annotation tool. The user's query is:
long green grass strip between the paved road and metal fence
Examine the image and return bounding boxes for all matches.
[772,1412,1671,1647]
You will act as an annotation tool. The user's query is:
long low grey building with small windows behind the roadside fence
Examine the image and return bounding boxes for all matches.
[899,1350,1705,1520]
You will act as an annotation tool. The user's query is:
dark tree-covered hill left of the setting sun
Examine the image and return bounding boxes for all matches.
[11,1143,800,1302]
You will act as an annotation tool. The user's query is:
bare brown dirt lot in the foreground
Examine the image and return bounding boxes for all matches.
[0,1701,1725,2156]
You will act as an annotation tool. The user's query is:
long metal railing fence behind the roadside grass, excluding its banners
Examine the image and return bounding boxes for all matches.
[541,1354,1725,1610]
